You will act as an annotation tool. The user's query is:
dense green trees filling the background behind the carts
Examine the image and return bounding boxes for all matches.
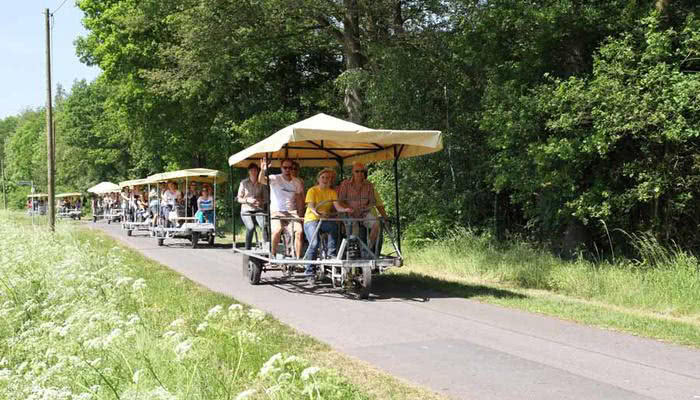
[0,0,700,255]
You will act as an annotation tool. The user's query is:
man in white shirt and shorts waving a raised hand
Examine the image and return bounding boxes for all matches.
[258,158,304,258]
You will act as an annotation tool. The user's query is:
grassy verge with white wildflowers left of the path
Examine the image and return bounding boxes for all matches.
[0,213,440,400]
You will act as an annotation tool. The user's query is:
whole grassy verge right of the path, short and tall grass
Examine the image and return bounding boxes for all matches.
[394,231,700,348]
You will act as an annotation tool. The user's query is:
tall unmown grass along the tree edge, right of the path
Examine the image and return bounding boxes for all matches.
[404,230,700,322]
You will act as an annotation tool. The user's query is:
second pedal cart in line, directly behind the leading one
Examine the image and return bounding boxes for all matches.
[147,168,226,248]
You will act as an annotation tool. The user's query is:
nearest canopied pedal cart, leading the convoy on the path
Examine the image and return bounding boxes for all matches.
[229,114,442,299]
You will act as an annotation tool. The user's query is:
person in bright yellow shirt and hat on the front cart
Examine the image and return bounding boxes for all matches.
[304,168,352,279]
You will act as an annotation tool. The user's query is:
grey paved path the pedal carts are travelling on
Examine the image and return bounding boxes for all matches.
[93,223,700,400]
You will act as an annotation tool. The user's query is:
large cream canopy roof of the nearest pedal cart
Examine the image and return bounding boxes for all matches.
[228,114,442,168]
